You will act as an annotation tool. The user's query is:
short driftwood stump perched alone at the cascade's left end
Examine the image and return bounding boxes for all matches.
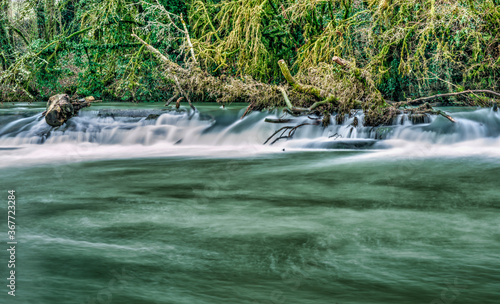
[42,94,95,127]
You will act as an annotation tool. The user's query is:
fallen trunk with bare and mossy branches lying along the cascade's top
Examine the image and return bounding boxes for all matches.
[132,34,500,131]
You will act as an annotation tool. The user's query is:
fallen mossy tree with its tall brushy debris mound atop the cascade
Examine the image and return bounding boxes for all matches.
[127,13,500,130]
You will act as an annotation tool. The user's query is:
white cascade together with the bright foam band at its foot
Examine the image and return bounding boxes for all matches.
[0,107,500,167]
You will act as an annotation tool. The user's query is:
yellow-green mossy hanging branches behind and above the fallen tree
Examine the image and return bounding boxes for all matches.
[190,0,500,100]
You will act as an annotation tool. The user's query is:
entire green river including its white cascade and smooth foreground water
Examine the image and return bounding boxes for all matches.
[0,104,500,304]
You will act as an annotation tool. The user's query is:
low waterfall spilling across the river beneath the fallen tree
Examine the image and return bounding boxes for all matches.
[0,105,500,163]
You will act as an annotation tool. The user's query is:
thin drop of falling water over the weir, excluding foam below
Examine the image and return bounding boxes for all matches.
[0,109,500,146]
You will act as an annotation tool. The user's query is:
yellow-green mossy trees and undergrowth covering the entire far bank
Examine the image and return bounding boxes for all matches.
[0,0,500,124]
